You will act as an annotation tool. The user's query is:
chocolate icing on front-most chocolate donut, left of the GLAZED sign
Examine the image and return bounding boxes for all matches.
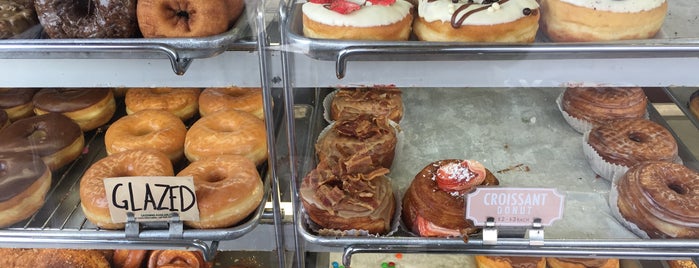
[0,152,48,202]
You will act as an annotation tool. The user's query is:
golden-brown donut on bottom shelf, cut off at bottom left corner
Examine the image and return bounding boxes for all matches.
[0,248,111,268]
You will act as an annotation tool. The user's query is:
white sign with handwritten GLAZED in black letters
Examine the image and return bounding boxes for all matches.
[104,177,199,223]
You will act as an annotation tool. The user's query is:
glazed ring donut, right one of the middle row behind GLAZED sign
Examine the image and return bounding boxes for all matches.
[184,110,267,165]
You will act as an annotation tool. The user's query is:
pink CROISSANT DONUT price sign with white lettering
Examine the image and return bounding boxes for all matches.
[466,187,564,226]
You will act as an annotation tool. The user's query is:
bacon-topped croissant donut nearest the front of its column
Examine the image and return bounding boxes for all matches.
[299,162,396,235]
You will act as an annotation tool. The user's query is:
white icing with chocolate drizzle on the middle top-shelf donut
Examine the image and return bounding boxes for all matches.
[417,0,539,25]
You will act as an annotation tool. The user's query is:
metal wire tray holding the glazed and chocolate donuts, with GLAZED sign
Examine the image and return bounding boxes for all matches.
[0,94,281,243]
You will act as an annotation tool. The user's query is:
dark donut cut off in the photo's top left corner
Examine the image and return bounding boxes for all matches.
[0,0,39,39]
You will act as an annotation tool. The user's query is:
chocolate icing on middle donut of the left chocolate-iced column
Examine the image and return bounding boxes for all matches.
[0,113,83,157]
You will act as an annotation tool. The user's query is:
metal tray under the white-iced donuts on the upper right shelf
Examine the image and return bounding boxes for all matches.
[281,0,699,78]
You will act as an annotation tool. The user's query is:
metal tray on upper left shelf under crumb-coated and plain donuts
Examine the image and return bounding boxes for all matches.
[0,1,277,75]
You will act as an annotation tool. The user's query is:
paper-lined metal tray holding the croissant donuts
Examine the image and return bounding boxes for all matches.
[297,88,699,255]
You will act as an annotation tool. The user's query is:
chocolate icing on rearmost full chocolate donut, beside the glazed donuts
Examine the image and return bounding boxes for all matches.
[33,88,111,113]
